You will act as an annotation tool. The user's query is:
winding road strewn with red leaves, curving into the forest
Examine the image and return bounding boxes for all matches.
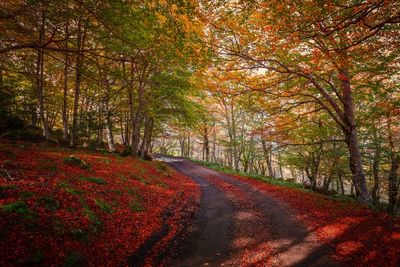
[161,157,335,266]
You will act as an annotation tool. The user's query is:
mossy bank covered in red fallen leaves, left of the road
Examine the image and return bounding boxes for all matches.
[0,143,200,266]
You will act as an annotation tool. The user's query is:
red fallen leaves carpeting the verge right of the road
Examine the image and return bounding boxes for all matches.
[235,176,400,266]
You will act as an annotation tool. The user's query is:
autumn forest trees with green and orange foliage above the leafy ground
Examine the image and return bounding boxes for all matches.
[0,0,400,266]
